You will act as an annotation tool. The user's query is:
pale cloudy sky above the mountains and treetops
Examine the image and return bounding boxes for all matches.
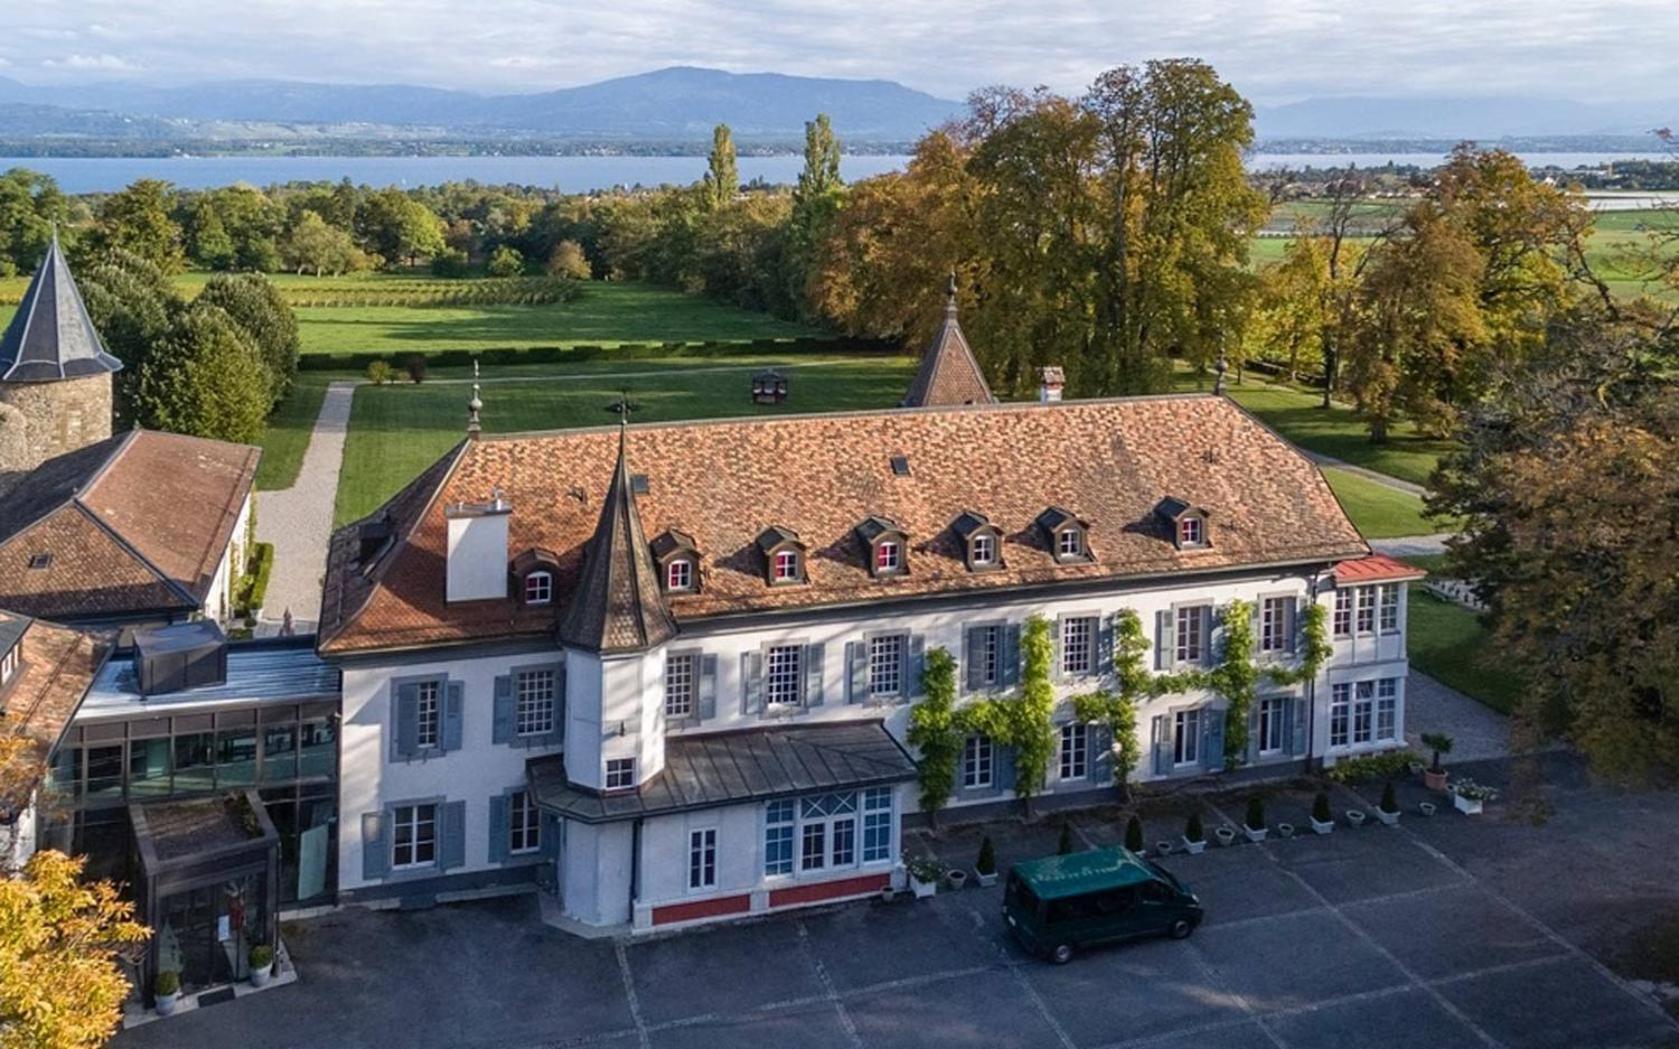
[0,0,1679,102]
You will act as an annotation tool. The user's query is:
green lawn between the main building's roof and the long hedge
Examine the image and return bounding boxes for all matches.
[334,357,917,525]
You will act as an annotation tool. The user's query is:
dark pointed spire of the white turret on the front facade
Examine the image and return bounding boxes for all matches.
[559,419,677,655]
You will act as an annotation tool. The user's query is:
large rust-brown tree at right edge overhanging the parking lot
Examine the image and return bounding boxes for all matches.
[1431,305,1679,782]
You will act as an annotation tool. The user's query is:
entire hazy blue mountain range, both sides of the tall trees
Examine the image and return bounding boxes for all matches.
[0,65,1679,146]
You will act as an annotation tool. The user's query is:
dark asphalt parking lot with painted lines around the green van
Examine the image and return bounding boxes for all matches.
[118,751,1679,1049]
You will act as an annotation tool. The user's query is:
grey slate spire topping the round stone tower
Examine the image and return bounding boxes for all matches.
[0,225,123,383]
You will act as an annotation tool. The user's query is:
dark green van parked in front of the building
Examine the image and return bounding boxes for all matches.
[1002,846,1204,965]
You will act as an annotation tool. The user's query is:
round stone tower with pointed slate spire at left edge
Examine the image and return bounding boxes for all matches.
[0,235,123,495]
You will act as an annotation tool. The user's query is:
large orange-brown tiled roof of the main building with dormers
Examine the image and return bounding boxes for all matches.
[321,394,1368,651]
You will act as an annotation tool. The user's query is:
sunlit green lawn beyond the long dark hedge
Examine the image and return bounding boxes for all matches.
[297,282,823,354]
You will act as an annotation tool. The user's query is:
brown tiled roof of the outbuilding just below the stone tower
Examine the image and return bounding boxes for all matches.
[0,430,262,618]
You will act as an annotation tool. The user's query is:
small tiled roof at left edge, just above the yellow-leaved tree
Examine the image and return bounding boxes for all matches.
[0,613,111,816]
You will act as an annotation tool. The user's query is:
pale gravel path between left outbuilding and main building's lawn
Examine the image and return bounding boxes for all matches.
[257,383,358,634]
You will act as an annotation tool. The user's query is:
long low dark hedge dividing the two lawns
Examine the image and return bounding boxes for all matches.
[297,336,903,373]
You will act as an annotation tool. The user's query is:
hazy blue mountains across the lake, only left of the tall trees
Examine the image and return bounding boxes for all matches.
[0,67,962,141]
